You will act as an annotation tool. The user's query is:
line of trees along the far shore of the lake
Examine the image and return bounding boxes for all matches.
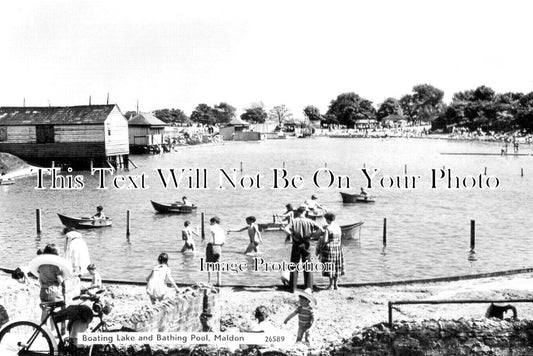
[130,84,533,131]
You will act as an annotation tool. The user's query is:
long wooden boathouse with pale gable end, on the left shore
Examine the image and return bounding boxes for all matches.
[0,105,129,168]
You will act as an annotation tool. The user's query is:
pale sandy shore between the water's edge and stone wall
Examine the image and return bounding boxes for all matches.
[0,273,533,353]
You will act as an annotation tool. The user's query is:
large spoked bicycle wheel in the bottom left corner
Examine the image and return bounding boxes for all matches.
[0,321,54,356]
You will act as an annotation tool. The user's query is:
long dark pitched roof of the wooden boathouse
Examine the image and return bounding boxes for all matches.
[0,104,120,126]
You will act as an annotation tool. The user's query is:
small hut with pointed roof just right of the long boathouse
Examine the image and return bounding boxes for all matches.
[128,113,167,152]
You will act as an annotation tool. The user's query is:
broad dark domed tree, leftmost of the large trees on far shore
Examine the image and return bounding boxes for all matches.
[328,93,376,127]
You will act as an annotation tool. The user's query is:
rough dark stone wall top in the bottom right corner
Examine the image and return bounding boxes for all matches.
[330,319,533,356]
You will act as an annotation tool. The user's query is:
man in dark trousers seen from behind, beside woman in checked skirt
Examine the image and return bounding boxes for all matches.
[285,205,324,292]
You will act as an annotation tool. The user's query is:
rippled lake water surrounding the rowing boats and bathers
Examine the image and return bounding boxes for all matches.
[0,137,533,285]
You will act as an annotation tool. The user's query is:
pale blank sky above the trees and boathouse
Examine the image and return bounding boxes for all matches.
[0,0,533,117]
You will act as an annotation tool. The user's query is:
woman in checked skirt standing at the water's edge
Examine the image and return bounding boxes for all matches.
[319,213,344,289]
